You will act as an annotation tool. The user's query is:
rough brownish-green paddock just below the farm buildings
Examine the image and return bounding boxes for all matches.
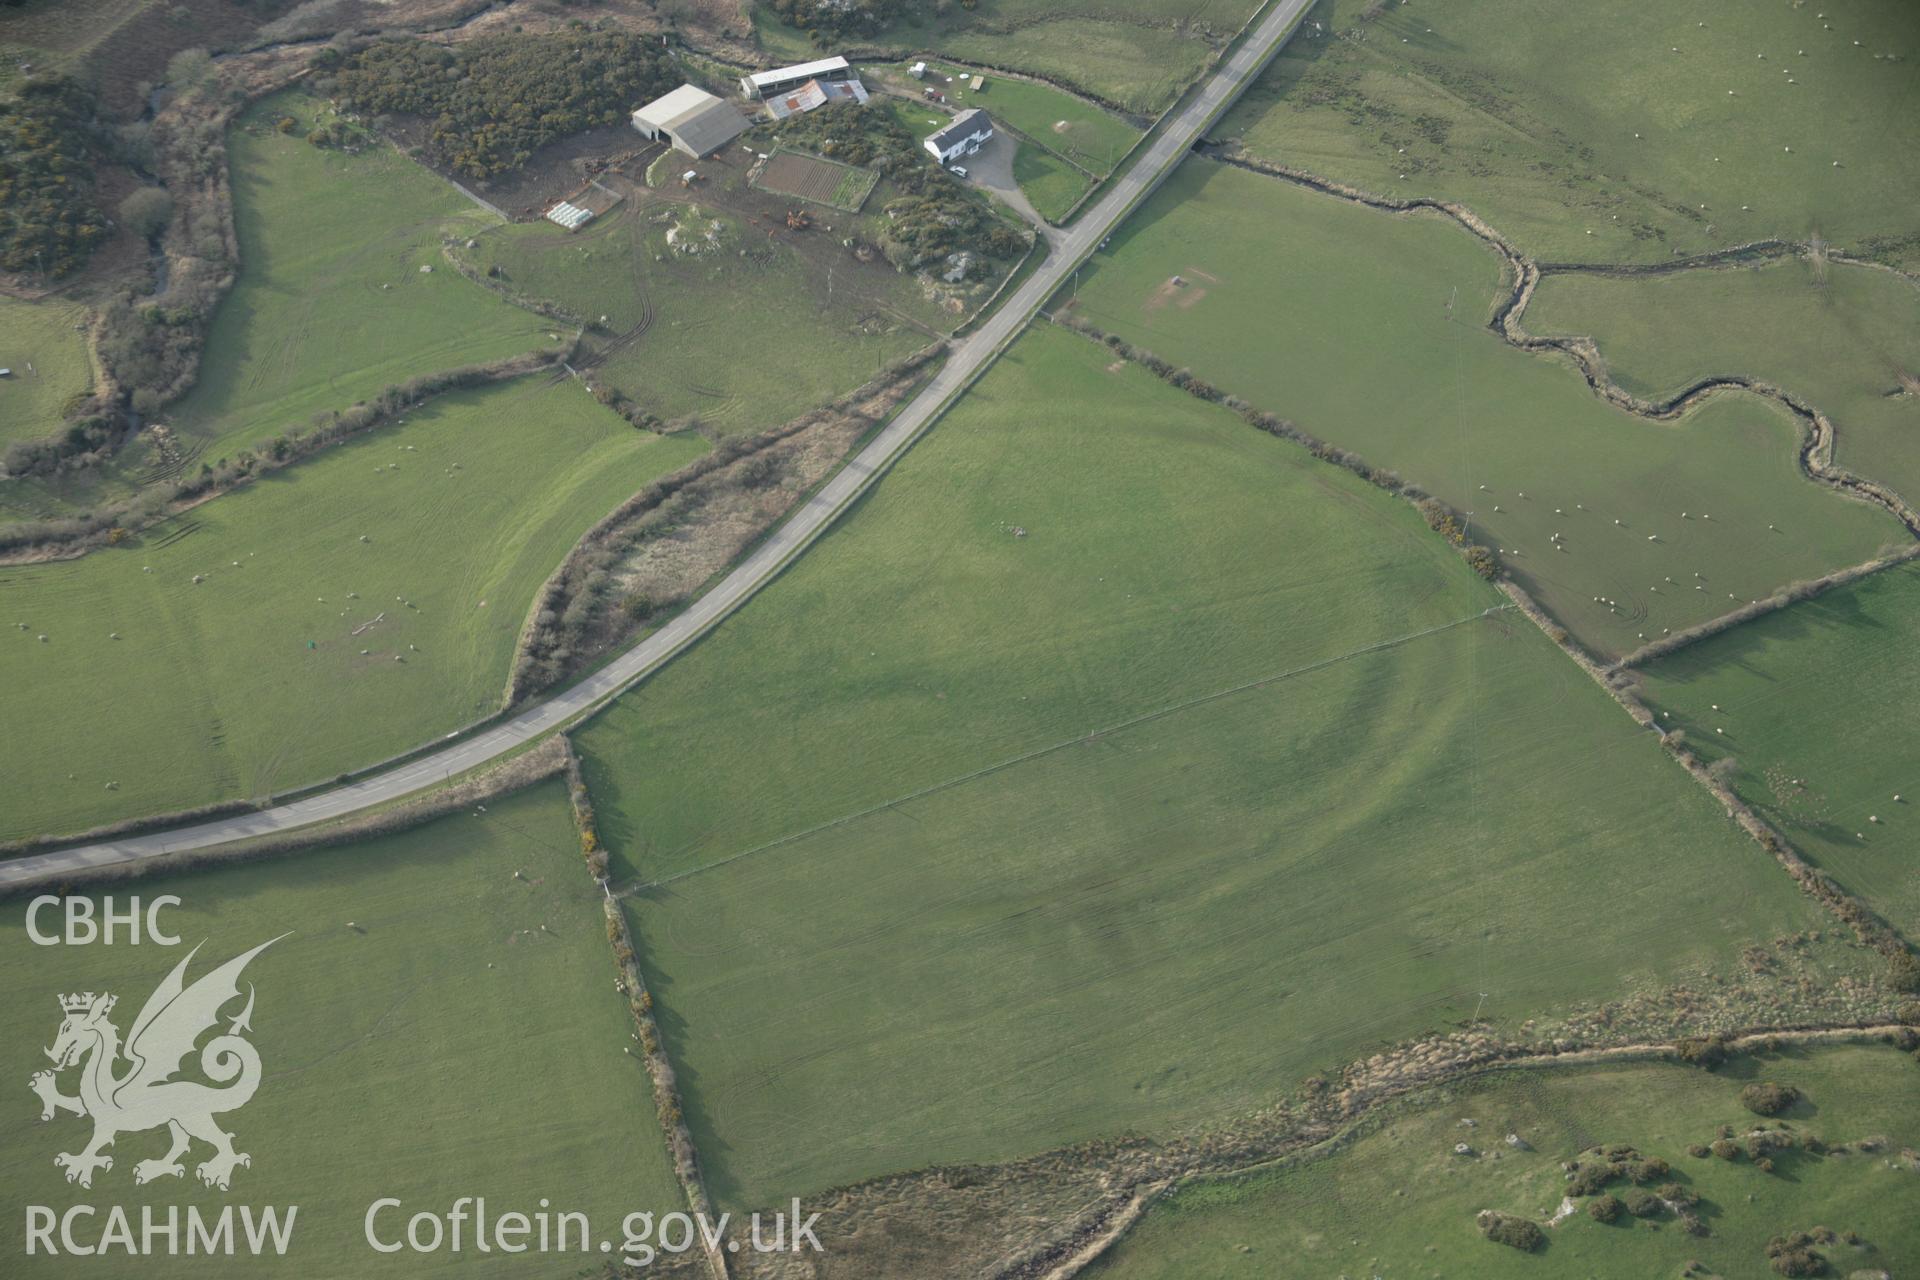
[461,195,954,434]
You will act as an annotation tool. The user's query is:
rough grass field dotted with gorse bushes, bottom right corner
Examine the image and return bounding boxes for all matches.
[1085,1044,1920,1280]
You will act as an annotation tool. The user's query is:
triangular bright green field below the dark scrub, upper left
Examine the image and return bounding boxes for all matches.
[0,92,570,518]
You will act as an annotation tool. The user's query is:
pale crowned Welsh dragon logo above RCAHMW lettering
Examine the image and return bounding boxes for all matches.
[29,933,286,1192]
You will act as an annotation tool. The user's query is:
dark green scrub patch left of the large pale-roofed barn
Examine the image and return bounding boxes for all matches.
[328,31,682,178]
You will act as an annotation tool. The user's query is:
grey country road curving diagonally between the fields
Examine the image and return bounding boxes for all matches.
[0,0,1309,887]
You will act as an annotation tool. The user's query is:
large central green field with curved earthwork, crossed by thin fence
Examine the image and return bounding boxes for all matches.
[578,328,1851,1207]
